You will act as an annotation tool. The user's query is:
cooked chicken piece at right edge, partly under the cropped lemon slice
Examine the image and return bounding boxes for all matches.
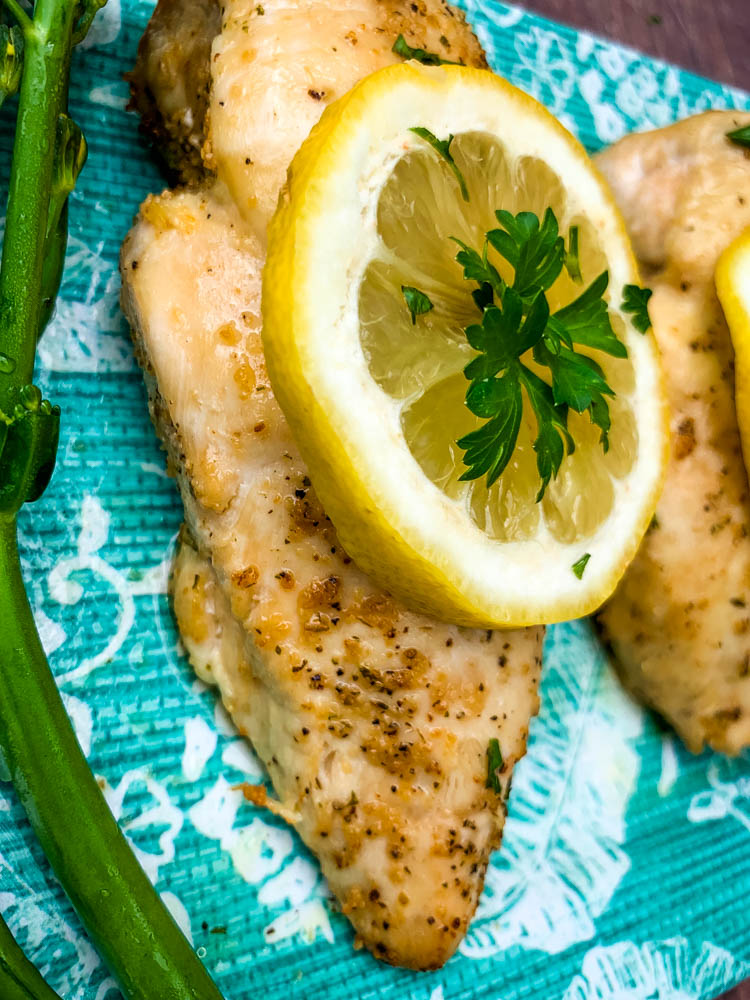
[598,112,750,754]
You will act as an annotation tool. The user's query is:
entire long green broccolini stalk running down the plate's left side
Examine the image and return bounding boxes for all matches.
[0,0,228,1000]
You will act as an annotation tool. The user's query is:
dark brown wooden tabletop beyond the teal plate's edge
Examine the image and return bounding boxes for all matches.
[523,9,750,1000]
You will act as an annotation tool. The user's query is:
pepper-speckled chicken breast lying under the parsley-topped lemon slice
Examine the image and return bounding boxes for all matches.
[122,0,543,968]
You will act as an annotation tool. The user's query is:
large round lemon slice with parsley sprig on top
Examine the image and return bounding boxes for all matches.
[263,64,666,627]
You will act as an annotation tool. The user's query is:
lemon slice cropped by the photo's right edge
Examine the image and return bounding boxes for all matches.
[716,229,750,469]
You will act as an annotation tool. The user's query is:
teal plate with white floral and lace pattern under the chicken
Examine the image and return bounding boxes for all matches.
[0,0,750,1000]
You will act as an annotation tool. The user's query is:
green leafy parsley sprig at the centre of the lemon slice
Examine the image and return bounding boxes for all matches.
[454,208,627,502]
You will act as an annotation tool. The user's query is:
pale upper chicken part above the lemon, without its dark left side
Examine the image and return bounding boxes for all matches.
[210,0,484,231]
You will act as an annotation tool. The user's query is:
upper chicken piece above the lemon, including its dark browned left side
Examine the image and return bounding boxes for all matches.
[128,0,486,199]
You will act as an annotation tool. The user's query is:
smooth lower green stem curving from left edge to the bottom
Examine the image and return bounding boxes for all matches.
[0,521,222,1000]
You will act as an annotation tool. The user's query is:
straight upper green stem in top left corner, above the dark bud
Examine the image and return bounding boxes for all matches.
[0,0,76,412]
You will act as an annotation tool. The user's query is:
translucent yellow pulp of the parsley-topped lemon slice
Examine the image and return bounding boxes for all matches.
[359,132,638,544]
